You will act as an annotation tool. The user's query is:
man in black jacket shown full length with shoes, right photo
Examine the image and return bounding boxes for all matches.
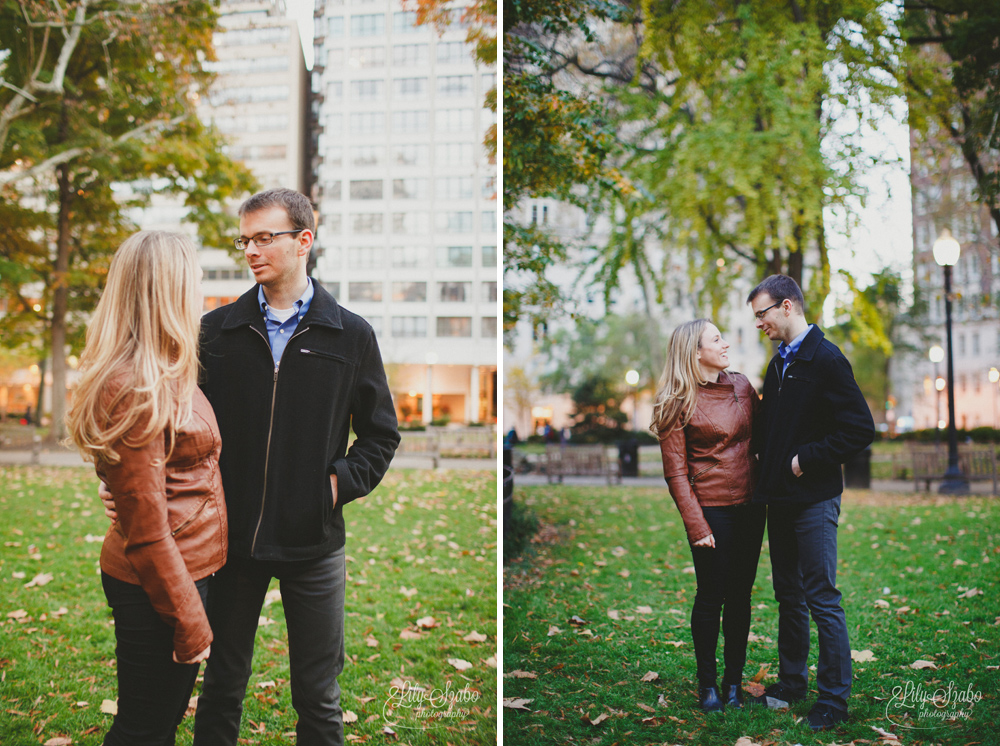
[747,275,875,731]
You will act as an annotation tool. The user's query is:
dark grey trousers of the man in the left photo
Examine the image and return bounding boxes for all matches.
[194,549,346,746]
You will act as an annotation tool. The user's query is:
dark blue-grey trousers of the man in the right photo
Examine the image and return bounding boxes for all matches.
[767,495,851,712]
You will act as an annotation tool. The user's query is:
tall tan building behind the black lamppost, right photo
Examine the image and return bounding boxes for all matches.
[893,128,1000,429]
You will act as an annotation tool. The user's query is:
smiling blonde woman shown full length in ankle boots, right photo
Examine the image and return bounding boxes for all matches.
[650,319,765,712]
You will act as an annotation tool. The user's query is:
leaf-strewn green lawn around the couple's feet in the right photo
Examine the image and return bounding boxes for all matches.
[503,486,1000,746]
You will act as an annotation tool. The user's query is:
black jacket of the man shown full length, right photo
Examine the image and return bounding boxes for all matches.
[754,326,875,503]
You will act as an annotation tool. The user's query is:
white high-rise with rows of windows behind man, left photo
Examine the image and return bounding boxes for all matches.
[312,0,498,423]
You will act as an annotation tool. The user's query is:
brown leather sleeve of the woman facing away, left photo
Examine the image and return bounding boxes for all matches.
[101,406,212,660]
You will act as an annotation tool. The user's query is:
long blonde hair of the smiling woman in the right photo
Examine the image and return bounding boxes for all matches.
[649,319,712,436]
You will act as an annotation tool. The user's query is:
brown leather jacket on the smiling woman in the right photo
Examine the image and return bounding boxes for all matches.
[660,372,760,543]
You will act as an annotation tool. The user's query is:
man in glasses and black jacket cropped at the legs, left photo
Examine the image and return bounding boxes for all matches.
[194,189,399,746]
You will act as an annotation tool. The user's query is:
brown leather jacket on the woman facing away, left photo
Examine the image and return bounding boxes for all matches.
[97,389,229,660]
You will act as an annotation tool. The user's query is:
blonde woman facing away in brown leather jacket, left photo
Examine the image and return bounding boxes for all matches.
[67,231,227,746]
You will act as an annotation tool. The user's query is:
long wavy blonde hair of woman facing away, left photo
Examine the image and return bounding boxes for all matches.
[66,231,201,463]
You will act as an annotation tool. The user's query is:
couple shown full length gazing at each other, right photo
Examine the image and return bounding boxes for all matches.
[651,275,875,731]
